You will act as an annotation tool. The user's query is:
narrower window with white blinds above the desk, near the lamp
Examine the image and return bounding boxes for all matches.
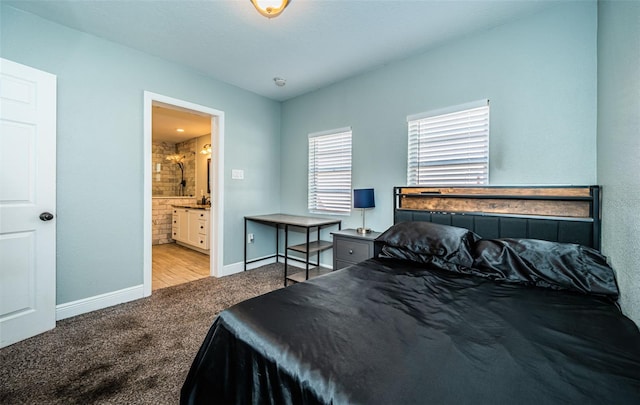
[309,128,351,214]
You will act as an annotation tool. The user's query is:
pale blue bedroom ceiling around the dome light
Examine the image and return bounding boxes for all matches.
[2,0,562,101]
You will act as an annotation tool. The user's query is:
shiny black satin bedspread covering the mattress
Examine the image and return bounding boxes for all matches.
[181,259,640,405]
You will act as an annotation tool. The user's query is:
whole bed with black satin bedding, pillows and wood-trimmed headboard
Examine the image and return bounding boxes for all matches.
[181,186,640,404]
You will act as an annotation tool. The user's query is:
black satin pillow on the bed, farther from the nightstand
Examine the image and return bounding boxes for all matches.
[473,239,618,299]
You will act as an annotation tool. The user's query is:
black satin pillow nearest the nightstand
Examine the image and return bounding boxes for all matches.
[376,222,479,267]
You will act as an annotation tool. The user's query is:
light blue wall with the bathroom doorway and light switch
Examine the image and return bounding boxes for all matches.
[0,5,281,304]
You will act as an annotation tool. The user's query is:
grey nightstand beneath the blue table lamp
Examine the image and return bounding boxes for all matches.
[331,229,381,270]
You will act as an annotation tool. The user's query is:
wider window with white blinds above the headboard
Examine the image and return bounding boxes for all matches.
[407,100,489,186]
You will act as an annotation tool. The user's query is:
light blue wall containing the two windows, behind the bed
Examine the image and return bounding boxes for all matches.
[281,2,597,237]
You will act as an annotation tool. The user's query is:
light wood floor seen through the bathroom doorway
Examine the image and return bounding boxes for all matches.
[151,243,209,290]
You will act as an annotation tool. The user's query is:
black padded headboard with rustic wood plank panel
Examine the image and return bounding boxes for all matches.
[393,186,601,250]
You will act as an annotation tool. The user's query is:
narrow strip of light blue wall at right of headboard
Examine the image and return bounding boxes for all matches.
[598,1,640,325]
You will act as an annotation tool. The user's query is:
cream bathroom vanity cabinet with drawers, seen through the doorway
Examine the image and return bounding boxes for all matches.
[171,205,210,254]
